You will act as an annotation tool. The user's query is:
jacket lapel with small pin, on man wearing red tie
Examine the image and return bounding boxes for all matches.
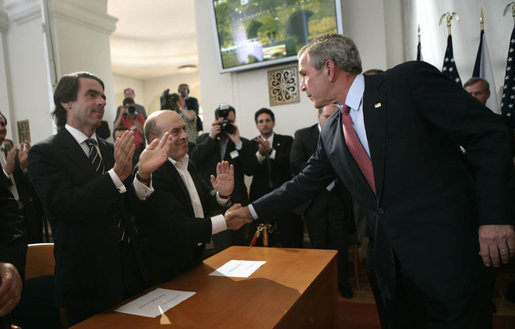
[363,75,387,204]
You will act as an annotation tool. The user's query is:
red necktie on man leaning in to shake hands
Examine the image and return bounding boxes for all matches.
[342,104,376,194]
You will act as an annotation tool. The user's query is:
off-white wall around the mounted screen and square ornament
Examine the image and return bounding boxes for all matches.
[195,0,402,137]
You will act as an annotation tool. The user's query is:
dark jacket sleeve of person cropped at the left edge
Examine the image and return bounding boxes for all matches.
[0,181,27,329]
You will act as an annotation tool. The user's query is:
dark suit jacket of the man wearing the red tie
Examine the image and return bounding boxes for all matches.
[254,62,513,300]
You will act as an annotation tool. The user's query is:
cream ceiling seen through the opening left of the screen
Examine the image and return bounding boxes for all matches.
[107,0,198,80]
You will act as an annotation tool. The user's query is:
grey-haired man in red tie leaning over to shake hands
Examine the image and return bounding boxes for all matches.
[228,34,515,328]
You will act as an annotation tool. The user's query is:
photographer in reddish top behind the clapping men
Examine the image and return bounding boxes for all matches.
[114,97,145,159]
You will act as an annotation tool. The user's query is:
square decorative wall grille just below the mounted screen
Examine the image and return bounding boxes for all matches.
[268,66,300,106]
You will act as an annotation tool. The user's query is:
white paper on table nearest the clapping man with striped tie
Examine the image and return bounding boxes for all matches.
[115,288,195,318]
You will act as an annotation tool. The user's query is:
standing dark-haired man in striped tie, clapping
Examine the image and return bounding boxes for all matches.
[28,72,170,325]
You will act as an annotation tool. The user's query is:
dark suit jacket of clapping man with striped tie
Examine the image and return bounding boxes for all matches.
[28,128,136,312]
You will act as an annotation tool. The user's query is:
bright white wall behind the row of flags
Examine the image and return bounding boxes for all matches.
[403,0,513,101]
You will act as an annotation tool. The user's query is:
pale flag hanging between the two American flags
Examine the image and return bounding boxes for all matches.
[472,30,501,114]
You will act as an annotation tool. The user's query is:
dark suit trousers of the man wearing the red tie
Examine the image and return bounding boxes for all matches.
[385,254,492,329]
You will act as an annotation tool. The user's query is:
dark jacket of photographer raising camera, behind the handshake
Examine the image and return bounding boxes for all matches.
[191,133,255,205]
